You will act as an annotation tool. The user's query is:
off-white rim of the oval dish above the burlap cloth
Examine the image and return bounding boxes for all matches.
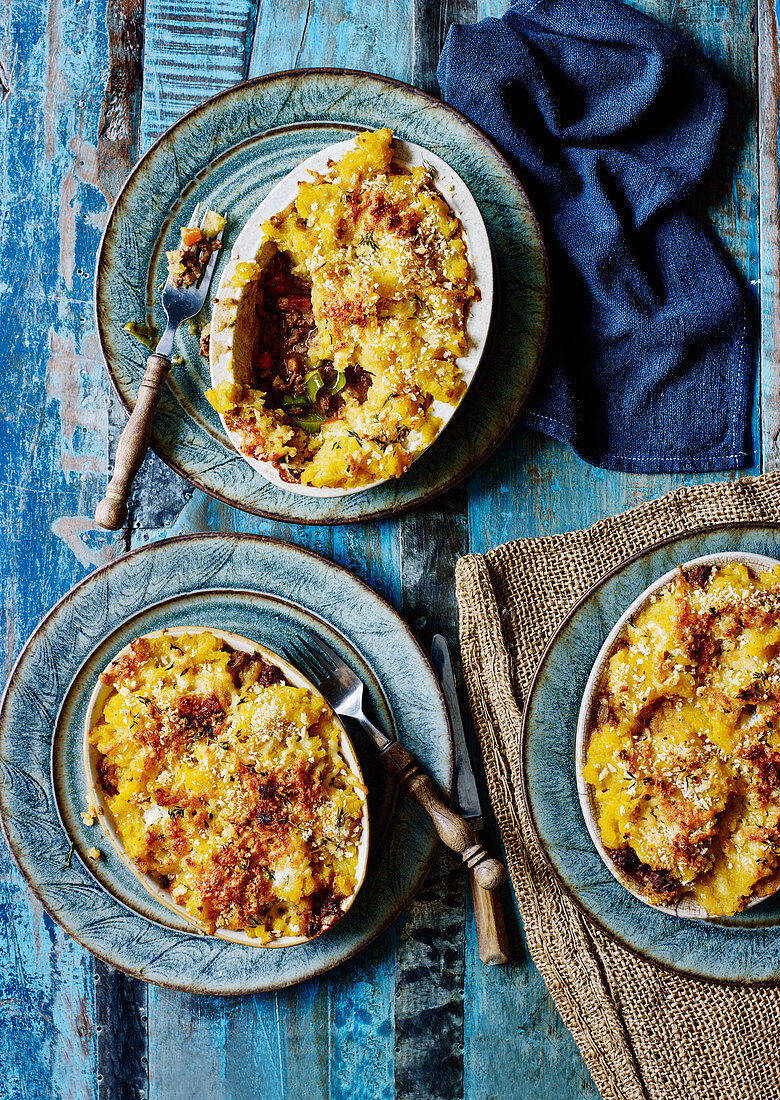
[574,551,780,920]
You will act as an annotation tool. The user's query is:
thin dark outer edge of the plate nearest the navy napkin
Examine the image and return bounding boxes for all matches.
[92,66,552,527]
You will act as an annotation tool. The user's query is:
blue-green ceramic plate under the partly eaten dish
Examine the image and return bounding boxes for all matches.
[95,69,548,524]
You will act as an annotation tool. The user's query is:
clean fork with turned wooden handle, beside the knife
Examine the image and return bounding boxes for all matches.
[283,636,506,890]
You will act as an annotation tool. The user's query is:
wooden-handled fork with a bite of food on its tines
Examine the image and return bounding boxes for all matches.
[95,202,222,531]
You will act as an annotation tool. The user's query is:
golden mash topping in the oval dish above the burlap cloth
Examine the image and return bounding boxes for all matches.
[584,562,780,916]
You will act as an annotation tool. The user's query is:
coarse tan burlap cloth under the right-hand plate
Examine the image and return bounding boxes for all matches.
[457,474,780,1100]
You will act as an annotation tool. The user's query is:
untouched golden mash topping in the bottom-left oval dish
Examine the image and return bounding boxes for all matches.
[90,631,365,943]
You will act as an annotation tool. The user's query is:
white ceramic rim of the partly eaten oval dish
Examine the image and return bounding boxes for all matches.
[210,133,493,498]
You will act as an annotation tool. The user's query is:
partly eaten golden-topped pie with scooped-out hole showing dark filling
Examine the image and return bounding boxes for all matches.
[207,129,479,490]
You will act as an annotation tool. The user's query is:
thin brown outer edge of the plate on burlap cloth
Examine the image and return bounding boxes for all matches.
[519,519,780,989]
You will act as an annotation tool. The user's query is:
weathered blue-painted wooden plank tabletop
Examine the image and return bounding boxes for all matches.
[0,0,765,1100]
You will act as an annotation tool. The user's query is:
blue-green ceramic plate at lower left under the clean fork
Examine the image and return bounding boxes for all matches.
[0,535,452,993]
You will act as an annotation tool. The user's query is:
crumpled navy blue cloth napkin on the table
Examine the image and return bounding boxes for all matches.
[438,0,752,473]
